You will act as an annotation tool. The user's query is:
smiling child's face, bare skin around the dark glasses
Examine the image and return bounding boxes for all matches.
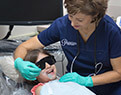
[37,53,56,83]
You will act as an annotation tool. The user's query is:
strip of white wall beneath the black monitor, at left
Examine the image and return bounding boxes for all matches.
[0,25,37,39]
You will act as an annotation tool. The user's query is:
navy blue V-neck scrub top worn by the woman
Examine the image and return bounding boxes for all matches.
[38,15,121,76]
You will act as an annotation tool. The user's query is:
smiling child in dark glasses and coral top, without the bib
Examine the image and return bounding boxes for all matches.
[24,49,56,95]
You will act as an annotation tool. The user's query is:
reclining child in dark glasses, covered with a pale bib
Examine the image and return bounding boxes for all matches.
[24,49,95,95]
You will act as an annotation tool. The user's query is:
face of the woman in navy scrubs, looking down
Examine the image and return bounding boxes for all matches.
[69,13,92,30]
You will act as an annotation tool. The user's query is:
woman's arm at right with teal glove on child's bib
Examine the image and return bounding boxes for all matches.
[59,57,121,87]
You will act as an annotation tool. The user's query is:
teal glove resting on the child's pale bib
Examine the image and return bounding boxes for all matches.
[59,72,93,87]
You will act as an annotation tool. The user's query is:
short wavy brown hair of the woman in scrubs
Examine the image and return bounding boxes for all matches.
[64,0,108,20]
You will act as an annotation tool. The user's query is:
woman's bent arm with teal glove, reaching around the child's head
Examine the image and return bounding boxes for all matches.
[14,36,44,80]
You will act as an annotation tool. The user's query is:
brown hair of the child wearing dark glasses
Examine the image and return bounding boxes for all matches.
[24,48,50,85]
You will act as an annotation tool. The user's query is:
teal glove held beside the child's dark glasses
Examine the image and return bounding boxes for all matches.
[14,58,41,80]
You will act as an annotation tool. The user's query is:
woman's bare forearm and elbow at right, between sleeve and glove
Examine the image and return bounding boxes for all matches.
[92,57,121,86]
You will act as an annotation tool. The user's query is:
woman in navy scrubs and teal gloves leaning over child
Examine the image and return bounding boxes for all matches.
[14,0,121,95]
